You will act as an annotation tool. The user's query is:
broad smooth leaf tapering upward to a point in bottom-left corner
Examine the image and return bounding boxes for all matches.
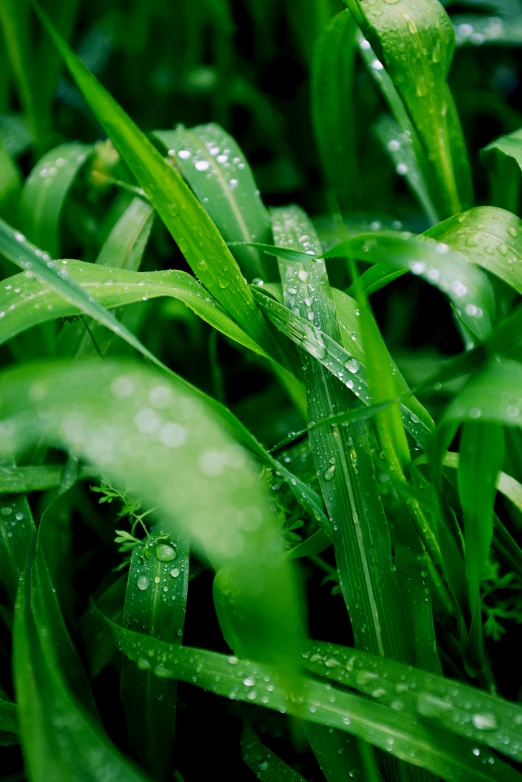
[13,546,148,782]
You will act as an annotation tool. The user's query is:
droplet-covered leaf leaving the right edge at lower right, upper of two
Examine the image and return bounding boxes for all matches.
[304,641,522,762]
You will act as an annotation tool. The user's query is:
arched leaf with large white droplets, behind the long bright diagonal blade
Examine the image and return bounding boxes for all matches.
[154,124,277,282]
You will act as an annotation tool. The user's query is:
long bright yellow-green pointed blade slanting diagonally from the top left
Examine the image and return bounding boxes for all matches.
[34,3,271,352]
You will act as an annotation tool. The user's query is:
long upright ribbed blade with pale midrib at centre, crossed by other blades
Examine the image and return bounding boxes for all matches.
[267,207,408,659]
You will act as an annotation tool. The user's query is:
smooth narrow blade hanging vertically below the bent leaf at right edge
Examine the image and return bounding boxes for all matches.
[458,421,504,671]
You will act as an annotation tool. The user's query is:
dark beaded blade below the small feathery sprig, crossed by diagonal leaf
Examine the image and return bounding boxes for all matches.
[120,530,189,779]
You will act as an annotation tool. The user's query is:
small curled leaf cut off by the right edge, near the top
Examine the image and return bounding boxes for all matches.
[481,130,522,212]
